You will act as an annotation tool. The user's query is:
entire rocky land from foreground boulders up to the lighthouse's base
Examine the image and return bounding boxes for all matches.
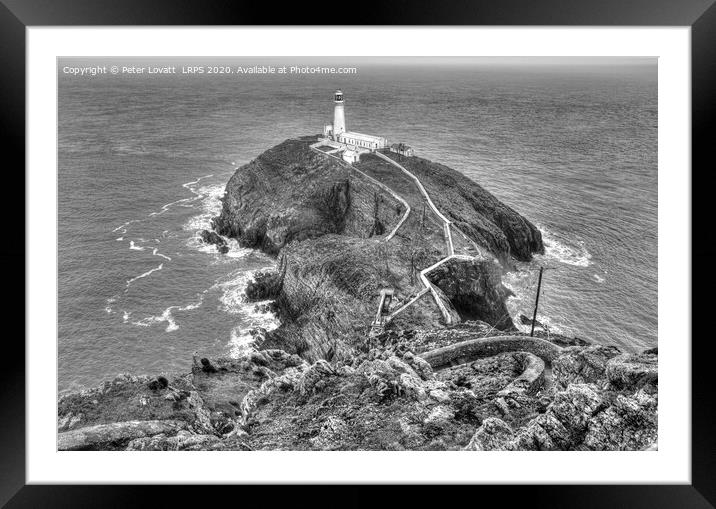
[58,136,658,451]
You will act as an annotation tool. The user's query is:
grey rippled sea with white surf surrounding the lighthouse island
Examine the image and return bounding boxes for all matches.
[58,58,657,390]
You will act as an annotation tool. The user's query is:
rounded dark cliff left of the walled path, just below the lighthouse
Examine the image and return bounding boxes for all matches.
[213,137,404,255]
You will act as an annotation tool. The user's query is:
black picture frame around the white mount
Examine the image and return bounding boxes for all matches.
[0,0,716,508]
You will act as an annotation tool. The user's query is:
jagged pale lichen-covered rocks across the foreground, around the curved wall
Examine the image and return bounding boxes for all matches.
[58,326,658,451]
